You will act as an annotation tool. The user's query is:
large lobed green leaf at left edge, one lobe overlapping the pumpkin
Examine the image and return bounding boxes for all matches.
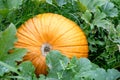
[0,24,27,76]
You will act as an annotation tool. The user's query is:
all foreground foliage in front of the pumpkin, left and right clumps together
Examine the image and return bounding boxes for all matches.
[0,24,120,80]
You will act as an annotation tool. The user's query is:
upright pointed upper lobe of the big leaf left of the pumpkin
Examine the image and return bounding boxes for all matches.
[0,24,17,59]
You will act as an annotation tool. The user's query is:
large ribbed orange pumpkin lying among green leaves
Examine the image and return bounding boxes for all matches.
[15,13,88,75]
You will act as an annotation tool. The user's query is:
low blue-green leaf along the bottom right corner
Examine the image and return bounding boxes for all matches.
[75,68,120,80]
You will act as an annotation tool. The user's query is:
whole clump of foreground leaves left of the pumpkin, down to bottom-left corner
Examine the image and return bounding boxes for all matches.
[0,24,36,80]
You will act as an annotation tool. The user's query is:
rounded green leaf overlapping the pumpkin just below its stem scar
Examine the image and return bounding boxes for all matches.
[46,51,69,71]
